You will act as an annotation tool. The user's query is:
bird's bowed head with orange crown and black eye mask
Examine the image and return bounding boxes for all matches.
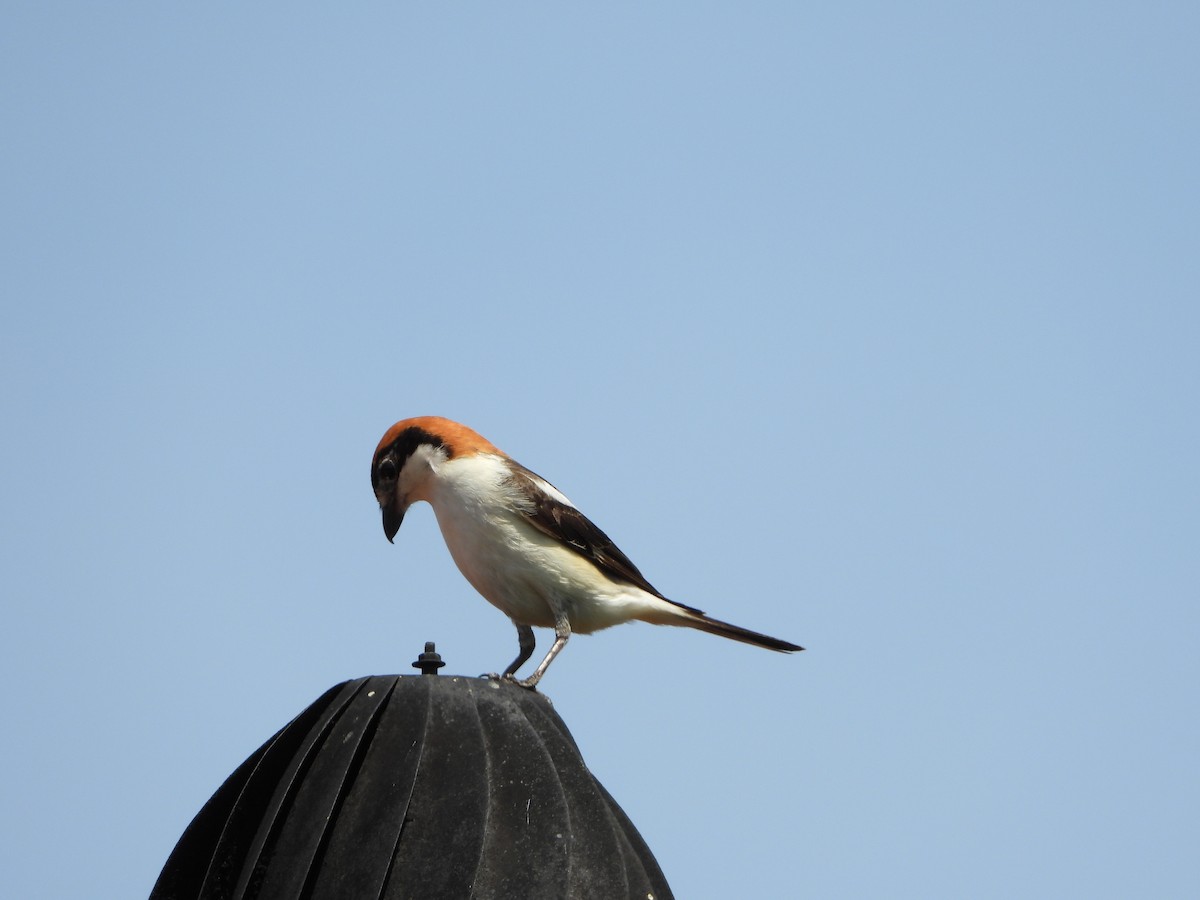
[371,415,500,541]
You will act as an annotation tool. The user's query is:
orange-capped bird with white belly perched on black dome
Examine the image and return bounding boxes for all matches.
[371,415,804,689]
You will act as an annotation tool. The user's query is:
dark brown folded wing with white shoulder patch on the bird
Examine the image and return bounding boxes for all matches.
[509,461,700,613]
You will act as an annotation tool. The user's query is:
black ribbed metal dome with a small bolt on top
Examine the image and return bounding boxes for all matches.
[150,648,671,900]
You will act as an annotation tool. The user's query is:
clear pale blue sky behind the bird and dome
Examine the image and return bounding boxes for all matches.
[0,2,1200,900]
